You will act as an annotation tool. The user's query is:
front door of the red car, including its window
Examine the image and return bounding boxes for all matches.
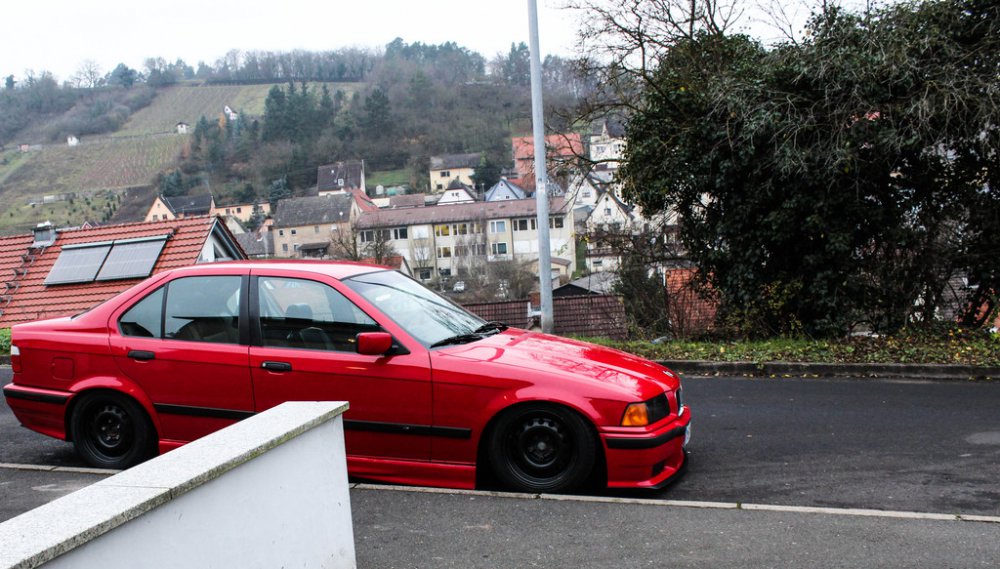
[249,269,431,460]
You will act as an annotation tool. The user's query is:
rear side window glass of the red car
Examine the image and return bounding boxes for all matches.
[118,276,241,344]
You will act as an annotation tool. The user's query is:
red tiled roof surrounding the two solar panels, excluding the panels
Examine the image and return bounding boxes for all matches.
[0,216,235,328]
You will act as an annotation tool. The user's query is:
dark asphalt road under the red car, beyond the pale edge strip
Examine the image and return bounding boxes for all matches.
[0,368,1000,520]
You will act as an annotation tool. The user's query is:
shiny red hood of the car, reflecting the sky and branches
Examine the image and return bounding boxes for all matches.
[437,329,680,398]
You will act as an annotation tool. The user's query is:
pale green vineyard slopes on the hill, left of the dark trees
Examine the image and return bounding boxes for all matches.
[0,83,357,235]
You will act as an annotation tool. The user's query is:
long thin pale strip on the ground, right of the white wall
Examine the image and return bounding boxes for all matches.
[351,484,1000,524]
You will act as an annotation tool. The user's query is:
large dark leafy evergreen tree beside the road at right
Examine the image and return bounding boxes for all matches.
[622,0,1000,335]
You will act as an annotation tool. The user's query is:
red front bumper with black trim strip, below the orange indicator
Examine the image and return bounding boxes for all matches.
[601,409,691,489]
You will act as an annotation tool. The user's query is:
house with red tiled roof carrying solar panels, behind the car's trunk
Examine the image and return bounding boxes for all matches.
[0,216,246,328]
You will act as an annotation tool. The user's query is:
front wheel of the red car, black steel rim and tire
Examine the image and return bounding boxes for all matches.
[487,403,597,493]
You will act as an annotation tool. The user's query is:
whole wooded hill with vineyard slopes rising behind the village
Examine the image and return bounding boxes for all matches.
[0,40,588,234]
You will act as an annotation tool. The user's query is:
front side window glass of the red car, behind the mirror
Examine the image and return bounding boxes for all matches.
[257,277,381,352]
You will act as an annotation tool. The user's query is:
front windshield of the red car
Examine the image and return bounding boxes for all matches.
[343,271,485,347]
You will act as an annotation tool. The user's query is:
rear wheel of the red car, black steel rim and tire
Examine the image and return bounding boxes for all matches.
[70,392,155,470]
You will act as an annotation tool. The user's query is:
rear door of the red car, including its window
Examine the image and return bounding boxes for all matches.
[110,269,254,442]
